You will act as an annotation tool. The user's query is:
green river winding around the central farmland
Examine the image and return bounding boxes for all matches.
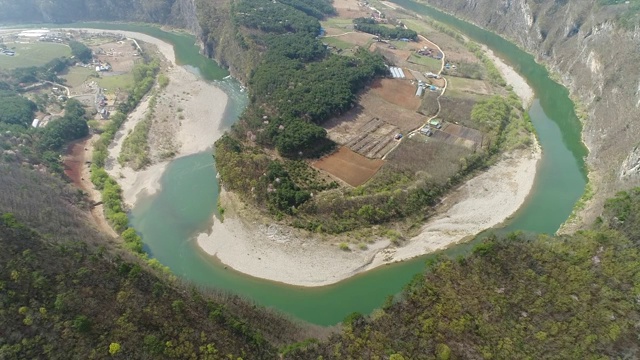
[69,10,586,325]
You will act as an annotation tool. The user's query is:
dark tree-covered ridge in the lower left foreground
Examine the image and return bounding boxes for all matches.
[0,213,310,360]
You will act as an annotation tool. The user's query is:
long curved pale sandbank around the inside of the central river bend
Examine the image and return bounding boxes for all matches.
[197,53,542,287]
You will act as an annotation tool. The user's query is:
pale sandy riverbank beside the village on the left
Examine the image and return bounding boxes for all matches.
[79,29,228,207]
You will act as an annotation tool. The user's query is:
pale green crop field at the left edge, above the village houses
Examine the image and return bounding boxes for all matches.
[0,42,71,70]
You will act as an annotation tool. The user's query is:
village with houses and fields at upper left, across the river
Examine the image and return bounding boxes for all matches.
[0,29,142,129]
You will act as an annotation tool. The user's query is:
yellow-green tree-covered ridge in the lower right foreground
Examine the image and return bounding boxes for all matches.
[288,188,640,359]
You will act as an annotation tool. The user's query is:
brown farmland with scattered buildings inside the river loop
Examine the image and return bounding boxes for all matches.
[313,0,505,186]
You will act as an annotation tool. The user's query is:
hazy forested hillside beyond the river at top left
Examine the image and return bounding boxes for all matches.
[0,0,197,30]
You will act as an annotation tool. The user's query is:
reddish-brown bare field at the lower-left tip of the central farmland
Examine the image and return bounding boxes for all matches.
[313,146,384,186]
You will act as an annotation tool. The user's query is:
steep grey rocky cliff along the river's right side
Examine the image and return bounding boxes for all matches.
[429,0,640,225]
